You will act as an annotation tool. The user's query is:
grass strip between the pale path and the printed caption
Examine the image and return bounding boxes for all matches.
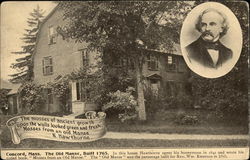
[1,131,248,149]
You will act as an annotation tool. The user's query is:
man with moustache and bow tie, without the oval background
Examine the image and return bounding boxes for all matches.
[186,9,233,68]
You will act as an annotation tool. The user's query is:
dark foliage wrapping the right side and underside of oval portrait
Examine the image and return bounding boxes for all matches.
[191,2,249,119]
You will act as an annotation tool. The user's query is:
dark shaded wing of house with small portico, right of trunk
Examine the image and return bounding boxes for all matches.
[112,44,188,96]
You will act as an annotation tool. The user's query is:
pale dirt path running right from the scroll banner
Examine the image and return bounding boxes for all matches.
[104,132,249,140]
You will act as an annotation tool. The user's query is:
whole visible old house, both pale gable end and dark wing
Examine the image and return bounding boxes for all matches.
[33,5,187,113]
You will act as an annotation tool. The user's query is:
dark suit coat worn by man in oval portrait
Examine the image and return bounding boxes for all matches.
[186,37,233,68]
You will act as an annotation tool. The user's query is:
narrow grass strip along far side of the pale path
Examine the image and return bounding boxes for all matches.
[107,121,248,135]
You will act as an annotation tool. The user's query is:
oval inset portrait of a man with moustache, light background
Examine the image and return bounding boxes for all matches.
[180,2,242,78]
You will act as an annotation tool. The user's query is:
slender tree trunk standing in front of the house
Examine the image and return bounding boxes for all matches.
[135,58,146,121]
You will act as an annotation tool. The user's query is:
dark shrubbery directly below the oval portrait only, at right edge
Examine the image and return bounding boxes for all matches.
[192,71,248,121]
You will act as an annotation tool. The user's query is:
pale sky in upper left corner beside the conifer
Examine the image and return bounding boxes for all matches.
[0,1,56,85]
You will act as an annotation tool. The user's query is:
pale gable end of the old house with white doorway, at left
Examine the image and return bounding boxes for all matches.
[33,8,98,112]
